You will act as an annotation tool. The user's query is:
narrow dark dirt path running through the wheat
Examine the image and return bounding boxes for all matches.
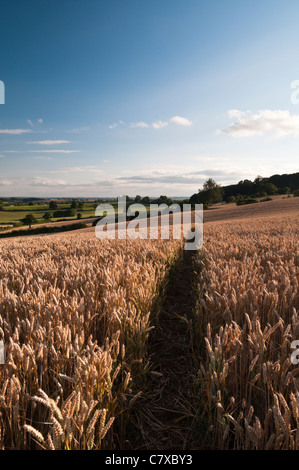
[135,251,196,450]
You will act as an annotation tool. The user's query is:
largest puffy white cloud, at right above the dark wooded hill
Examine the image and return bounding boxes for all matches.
[217,110,299,137]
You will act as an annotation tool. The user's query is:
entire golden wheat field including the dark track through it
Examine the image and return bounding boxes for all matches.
[0,198,299,450]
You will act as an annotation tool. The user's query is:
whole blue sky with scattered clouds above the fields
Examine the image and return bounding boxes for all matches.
[0,0,299,197]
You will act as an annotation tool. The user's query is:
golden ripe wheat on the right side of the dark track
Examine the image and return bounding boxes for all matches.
[196,213,299,449]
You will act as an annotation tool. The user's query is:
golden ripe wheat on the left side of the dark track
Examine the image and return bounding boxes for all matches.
[0,234,177,449]
